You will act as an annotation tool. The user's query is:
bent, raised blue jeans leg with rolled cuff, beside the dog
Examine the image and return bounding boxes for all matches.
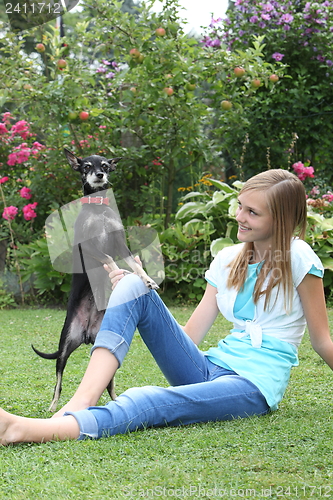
[92,274,208,385]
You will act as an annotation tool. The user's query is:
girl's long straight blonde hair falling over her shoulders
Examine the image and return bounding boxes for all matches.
[227,169,307,312]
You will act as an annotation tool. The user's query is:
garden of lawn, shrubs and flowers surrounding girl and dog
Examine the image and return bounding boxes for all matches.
[0,0,333,499]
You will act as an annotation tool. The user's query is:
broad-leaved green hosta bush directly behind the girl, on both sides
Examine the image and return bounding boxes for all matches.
[160,172,333,302]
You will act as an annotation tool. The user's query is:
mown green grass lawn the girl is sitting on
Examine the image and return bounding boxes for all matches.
[0,307,333,500]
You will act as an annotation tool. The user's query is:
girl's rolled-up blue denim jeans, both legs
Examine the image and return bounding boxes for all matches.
[66,274,269,439]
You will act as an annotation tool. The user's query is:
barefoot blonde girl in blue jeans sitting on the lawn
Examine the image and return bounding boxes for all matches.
[0,170,333,445]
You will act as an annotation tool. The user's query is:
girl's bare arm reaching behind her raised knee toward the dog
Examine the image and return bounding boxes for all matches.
[184,283,219,345]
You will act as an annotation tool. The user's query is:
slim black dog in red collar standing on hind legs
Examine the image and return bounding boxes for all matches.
[32,149,158,411]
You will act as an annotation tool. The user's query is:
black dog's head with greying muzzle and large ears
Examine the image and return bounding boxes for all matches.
[64,149,121,194]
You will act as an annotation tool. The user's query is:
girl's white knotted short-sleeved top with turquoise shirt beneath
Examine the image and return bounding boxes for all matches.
[205,239,323,410]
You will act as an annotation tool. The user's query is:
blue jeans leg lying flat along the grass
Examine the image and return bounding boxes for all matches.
[70,369,269,439]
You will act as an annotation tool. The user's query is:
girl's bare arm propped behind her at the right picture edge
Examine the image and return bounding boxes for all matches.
[297,274,333,370]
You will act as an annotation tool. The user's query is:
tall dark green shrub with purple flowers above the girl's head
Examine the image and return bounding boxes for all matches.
[203,0,333,183]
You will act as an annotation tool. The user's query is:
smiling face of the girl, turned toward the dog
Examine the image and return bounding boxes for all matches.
[236,190,273,252]
